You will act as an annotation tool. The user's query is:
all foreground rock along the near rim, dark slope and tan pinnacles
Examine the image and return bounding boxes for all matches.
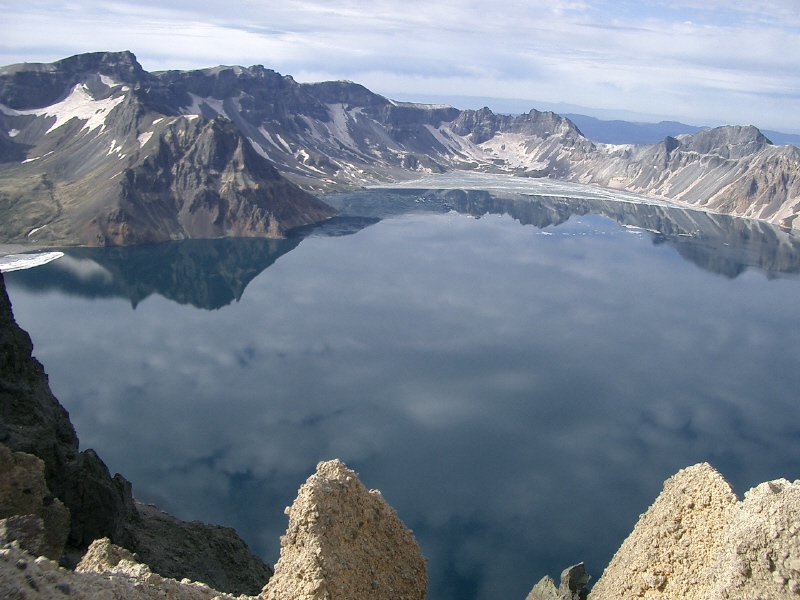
[0,264,800,600]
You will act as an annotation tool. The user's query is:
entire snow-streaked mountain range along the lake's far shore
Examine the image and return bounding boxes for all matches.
[0,52,800,246]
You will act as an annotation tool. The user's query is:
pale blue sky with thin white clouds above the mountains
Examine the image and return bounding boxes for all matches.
[0,0,800,133]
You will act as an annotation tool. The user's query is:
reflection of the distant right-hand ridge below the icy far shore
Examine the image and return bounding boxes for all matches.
[327,189,800,277]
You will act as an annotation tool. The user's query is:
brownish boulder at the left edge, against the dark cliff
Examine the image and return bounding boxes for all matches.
[0,444,70,560]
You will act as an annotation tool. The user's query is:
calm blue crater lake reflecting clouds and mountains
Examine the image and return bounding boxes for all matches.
[6,178,800,600]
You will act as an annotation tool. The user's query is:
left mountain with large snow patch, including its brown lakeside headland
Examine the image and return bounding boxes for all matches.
[0,53,335,246]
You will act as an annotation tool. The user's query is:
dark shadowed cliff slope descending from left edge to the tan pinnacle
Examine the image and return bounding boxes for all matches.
[0,275,272,595]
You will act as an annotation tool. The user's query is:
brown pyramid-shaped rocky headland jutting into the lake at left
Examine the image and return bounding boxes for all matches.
[97,118,335,246]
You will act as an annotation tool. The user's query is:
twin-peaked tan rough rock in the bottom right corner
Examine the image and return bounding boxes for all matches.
[589,463,800,600]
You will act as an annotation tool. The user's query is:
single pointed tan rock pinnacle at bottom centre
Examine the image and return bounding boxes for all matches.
[261,460,427,600]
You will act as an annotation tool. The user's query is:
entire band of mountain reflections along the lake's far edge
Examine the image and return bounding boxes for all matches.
[9,189,800,309]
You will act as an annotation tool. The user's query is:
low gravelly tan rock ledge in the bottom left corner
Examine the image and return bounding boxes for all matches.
[0,539,244,600]
